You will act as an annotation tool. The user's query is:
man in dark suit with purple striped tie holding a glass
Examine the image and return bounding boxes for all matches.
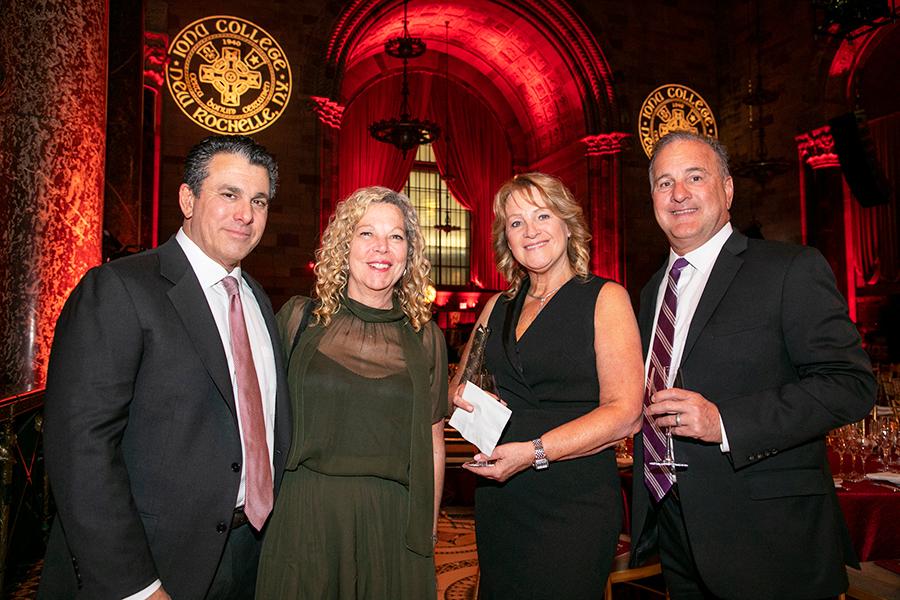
[632,132,874,600]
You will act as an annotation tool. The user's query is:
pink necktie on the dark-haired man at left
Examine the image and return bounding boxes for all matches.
[222,275,274,531]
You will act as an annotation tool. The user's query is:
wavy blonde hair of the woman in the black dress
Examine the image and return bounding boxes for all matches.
[493,172,591,297]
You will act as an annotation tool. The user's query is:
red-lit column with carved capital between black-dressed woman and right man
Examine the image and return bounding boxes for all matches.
[581,132,631,285]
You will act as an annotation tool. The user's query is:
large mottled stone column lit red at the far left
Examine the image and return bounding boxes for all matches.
[0,0,107,396]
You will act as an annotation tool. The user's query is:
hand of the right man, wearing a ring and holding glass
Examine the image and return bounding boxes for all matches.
[646,388,722,444]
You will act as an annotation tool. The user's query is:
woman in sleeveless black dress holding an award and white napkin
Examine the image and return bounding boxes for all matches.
[451,173,642,600]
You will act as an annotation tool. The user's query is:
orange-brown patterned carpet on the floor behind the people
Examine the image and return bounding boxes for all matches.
[6,508,478,600]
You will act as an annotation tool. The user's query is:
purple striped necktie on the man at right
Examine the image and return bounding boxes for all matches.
[641,258,689,502]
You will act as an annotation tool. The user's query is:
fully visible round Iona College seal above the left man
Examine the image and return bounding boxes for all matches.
[166,16,291,135]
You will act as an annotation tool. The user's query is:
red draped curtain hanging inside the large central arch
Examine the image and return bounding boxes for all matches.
[334,73,512,289]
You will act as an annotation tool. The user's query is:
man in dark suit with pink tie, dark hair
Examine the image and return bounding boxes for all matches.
[39,136,291,600]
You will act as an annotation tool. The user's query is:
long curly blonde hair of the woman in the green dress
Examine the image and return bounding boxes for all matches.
[313,186,431,331]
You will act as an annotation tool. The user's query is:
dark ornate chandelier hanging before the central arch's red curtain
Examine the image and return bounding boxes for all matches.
[369,0,441,158]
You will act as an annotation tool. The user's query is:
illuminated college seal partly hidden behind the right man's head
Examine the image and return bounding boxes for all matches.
[638,83,718,158]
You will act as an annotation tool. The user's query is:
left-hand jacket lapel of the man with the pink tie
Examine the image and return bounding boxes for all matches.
[158,237,237,422]
